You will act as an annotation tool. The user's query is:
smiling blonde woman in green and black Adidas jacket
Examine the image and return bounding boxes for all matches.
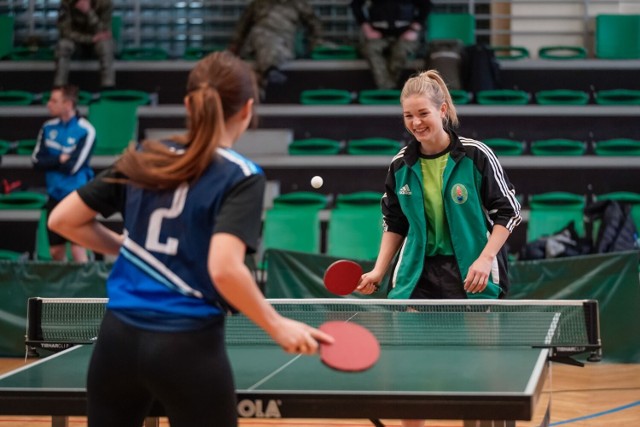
[358,70,520,427]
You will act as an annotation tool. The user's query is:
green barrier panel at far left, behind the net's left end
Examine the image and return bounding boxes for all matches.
[0,261,111,357]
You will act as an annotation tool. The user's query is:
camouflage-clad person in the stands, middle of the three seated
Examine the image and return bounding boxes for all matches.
[228,0,322,89]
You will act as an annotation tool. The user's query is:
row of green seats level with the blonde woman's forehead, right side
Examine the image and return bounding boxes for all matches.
[300,89,640,105]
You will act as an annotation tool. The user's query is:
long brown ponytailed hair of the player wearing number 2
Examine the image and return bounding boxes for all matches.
[115,52,257,190]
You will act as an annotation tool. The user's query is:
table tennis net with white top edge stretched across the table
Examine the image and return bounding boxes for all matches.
[27,298,600,353]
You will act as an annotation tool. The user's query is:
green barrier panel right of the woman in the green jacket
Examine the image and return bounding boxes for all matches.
[509,251,640,363]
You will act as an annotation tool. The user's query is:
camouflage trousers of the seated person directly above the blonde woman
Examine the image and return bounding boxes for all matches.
[360,37,420,89]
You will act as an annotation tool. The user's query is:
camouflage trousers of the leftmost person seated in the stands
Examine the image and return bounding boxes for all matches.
[53,39,116,87]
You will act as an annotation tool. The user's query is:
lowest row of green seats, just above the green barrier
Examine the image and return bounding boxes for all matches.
[0,191,640,260]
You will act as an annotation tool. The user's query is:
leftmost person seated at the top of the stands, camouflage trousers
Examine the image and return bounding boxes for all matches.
[53,0,116,88]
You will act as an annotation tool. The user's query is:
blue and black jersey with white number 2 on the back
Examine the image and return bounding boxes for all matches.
[78,148,265,330]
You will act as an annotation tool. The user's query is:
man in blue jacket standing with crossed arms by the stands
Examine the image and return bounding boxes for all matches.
[32,85,96,262]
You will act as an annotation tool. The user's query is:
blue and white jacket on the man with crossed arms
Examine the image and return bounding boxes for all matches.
[31,115,96,200]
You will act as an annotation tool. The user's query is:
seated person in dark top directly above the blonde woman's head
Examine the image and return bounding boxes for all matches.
[351,0,431,89]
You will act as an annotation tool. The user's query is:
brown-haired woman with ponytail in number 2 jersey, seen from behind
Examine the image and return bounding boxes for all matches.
[49,52,332,427]
